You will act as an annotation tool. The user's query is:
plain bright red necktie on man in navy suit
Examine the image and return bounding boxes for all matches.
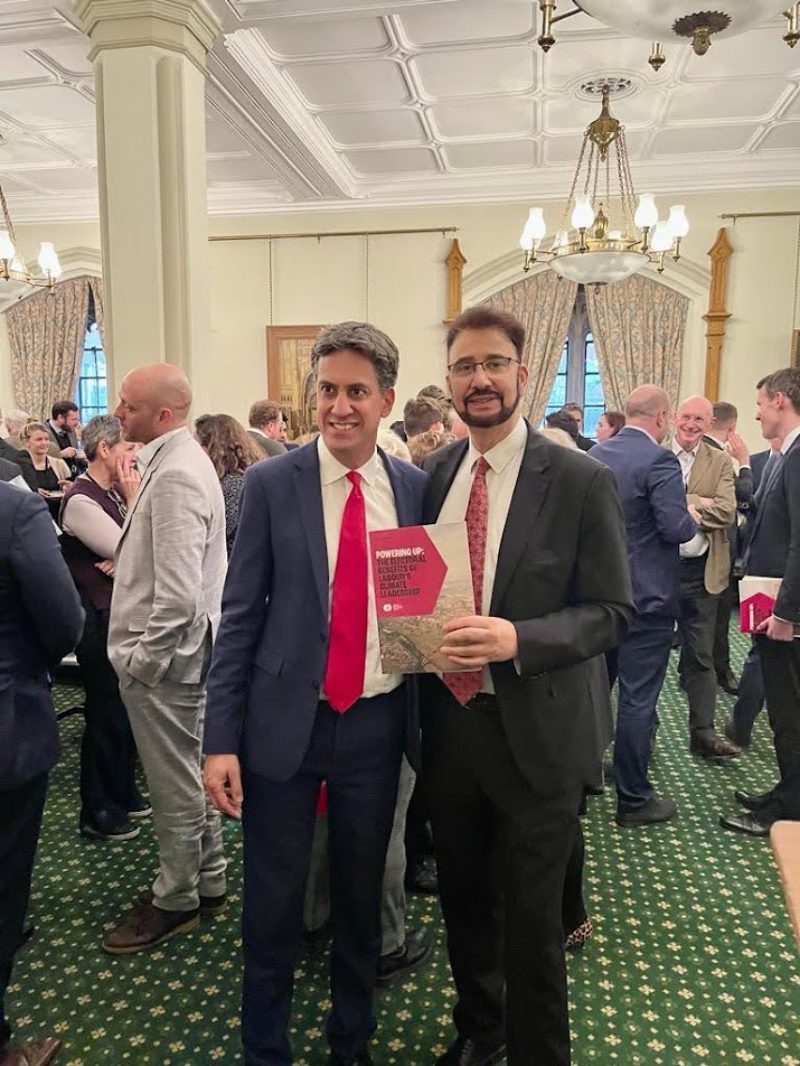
[324,470,368,714]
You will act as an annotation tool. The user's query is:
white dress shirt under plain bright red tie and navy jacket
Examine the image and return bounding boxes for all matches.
[317,436,403,699]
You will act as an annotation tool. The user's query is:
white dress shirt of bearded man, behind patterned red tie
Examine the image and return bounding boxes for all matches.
[436,418,528,693]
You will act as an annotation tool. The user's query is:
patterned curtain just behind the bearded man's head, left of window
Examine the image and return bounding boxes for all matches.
[486,270,578,425]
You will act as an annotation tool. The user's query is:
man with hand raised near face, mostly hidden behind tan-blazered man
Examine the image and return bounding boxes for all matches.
[703,400,754,696]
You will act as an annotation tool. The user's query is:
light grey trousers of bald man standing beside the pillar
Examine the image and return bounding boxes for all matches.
[119,675,226,910]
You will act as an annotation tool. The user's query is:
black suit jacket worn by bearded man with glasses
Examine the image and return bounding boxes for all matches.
[420,425,634,793]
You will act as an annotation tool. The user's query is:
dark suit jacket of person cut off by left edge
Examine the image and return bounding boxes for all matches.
[0,483,83,790]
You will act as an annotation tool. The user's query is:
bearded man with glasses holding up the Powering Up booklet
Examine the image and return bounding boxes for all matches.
[420,305,633,1066]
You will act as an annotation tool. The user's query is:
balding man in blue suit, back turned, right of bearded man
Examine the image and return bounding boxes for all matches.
[590,385,698,828]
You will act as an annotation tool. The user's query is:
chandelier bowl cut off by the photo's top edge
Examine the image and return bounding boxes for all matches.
[539,0,800,70]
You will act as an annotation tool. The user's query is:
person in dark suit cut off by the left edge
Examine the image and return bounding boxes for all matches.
[0,483,83,1066]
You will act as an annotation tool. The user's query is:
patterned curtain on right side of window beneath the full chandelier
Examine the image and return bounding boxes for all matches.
[586,274,689,410]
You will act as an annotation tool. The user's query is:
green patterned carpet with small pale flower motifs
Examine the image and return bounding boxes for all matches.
[6,634,800,1066]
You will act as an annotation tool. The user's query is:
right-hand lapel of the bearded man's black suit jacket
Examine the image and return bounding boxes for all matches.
[490,425,551,614]
